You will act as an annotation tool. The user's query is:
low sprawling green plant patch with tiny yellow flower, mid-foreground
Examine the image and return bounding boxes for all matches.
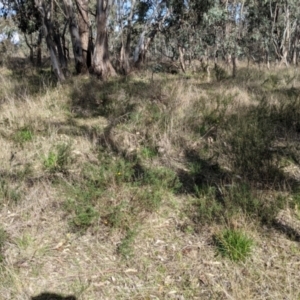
[62,152,181,230]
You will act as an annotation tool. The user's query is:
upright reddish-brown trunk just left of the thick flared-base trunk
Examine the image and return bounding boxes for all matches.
[76,0,91,73]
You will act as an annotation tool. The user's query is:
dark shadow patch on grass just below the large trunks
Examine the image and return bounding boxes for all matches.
[70,77,169,120]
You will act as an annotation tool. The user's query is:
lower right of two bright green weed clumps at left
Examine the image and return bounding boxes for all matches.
[43,144,72,173]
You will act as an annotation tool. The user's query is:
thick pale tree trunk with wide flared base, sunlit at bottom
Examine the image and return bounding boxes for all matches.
[92,0,116,80]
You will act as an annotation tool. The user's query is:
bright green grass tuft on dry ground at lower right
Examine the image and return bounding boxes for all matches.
[214,229,253,261]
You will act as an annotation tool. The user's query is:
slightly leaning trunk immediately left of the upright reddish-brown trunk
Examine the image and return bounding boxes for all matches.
[64,0,86,74]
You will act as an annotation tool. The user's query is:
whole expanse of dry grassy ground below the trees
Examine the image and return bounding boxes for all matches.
[0,59,300,300]
